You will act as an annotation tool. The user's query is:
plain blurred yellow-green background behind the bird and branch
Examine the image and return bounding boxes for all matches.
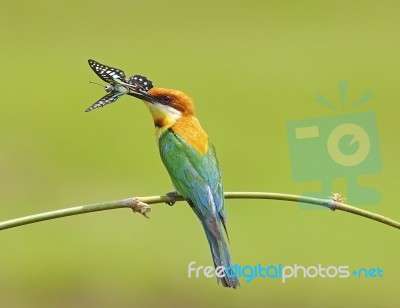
[0,0,400,307]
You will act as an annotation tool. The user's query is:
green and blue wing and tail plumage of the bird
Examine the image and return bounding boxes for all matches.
[159,129,239,287]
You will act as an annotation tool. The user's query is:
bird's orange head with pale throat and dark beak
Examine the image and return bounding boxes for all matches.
[129,88,195,128]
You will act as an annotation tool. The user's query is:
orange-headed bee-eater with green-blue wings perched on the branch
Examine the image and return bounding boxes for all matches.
[128,83,240,289]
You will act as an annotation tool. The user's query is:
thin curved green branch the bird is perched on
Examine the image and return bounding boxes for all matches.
[0,192,400,230]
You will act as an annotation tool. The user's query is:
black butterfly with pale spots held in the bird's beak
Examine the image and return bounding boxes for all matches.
[85,59,153,112]
